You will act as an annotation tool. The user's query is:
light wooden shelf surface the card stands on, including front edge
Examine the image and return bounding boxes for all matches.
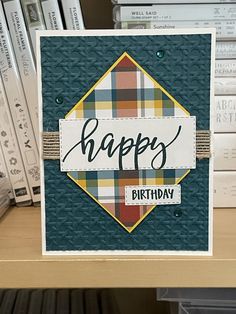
[0,207,236,288]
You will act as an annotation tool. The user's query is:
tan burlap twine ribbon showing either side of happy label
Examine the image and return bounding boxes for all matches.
[43,130,211,160]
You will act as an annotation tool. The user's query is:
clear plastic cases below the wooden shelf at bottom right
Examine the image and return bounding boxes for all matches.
[157,288,236,314]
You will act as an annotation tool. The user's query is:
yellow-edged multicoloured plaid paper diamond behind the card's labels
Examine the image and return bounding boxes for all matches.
[66,52,189,232]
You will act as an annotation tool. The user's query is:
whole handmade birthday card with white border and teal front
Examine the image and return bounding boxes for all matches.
[37,29,215,256]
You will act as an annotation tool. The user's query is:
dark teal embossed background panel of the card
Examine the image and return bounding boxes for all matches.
[41,35,211,251]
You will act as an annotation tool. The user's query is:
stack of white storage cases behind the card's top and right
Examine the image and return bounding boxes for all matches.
[113,0,236,207]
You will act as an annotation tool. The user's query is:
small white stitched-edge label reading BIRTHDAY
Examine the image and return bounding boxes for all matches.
[125,185,181,205]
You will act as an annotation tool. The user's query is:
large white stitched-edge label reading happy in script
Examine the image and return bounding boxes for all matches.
[60,117,196,171]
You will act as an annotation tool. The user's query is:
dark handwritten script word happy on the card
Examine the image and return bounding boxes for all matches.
[62,118,182,170]
